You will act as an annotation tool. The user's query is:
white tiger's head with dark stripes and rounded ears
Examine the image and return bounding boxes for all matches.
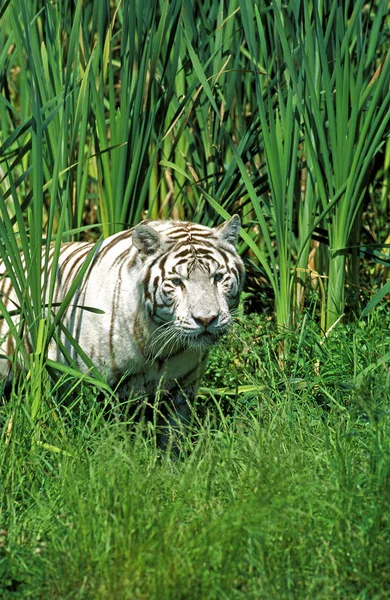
[132,215,244,348]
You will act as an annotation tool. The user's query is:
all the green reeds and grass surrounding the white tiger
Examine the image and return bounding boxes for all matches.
[0,0,390,600]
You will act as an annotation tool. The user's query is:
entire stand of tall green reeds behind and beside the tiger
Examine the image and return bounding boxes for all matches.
[0,0,390,386]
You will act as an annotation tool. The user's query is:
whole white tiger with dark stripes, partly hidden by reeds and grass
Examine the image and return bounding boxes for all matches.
[0,215,244,446]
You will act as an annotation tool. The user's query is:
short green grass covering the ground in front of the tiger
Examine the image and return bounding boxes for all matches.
[0,316,390,600]
